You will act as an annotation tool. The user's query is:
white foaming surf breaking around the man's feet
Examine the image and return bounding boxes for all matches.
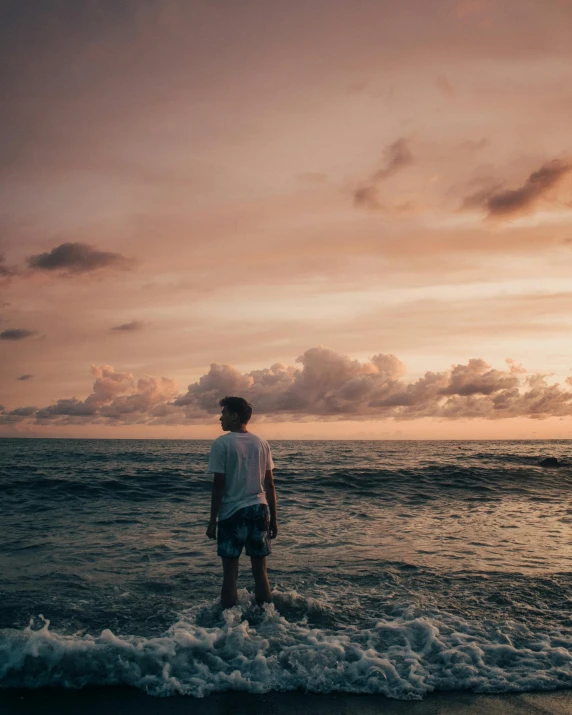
[0,591,572,699]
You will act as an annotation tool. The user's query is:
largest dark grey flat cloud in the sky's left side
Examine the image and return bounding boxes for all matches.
[27,243,131,274]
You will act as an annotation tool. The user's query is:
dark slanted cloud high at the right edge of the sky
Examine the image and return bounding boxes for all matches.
[463,160,572,218]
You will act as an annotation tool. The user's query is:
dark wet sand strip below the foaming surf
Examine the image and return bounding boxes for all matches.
[0,686,572,715]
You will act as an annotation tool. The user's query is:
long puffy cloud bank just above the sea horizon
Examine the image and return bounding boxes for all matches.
[4,347,572,425]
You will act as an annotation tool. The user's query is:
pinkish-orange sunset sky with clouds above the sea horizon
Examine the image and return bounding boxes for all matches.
[0,0,572,439]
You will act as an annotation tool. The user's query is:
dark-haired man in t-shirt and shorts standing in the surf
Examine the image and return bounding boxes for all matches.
[207,397,278,608]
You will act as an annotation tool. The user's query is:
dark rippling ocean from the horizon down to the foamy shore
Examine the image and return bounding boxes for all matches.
[0,440,572,700]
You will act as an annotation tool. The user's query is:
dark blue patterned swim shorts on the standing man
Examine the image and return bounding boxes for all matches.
[217,504,271,559]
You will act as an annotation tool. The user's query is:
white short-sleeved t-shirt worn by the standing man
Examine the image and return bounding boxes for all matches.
[208,432,274,521]
